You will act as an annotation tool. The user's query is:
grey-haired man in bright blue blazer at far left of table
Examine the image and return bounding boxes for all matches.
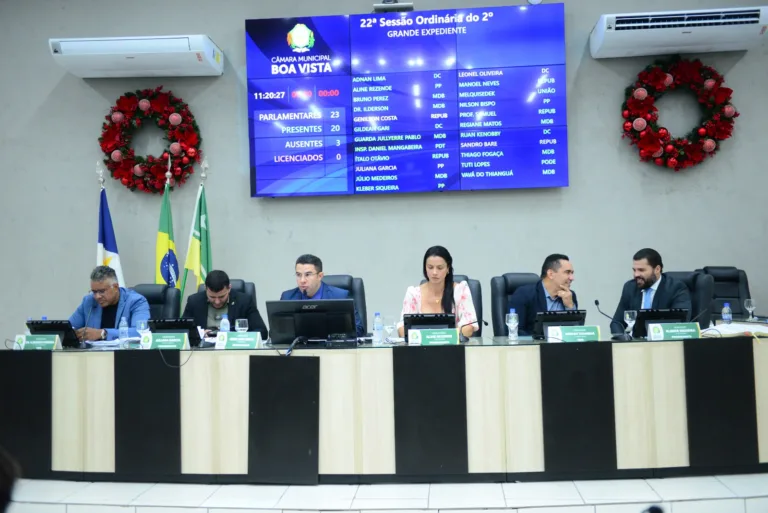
[69,265,149,341]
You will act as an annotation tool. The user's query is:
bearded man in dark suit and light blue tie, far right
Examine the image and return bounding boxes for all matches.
[611,248,691,333]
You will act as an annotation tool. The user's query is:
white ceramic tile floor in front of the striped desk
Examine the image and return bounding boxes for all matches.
[10,474,768,513]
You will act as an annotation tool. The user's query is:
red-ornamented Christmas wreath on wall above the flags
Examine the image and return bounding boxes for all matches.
[99,86,202,193]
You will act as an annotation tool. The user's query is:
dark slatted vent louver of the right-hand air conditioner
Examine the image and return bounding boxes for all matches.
[615,9,760,30]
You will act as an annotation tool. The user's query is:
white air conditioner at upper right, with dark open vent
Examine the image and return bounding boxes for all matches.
[589,7,768,59]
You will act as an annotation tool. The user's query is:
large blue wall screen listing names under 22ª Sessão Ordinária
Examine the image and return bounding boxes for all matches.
[245,4,568,197]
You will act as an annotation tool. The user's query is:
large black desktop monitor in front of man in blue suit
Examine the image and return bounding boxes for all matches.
[267,299,357,344]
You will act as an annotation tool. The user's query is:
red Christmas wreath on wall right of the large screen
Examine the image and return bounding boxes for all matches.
[622,57,739,171]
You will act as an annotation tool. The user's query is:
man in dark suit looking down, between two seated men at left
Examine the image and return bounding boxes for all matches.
[182,271,269,340]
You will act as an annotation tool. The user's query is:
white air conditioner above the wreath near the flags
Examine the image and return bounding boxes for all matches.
[48,35,224,78]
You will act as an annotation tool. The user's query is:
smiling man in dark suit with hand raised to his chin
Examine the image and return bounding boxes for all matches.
[509,253,579,336]
